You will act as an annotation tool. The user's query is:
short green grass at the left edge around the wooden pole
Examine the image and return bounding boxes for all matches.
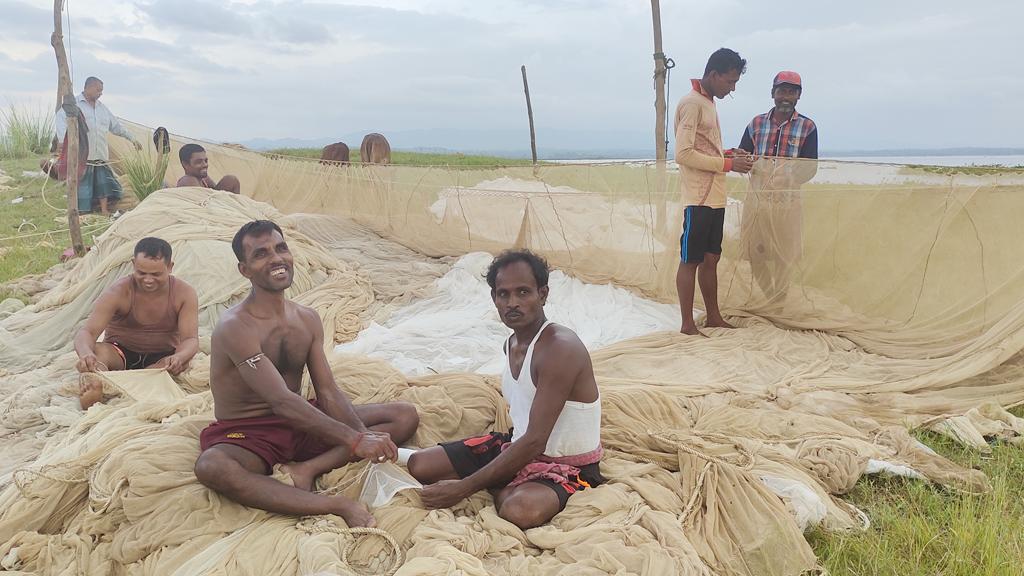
[0,157,110,300]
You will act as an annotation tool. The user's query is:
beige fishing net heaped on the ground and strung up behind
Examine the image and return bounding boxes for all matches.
[0,123,1024,575]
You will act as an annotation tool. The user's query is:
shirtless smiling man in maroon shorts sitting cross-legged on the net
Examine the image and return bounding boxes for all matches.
[196,220,419,527]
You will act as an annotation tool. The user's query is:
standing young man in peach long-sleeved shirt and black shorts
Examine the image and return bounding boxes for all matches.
[676,48,754,335]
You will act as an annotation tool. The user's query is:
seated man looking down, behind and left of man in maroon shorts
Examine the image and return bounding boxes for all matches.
[75,238,199,409]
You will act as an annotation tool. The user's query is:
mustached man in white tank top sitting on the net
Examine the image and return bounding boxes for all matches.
[409,250,604,530]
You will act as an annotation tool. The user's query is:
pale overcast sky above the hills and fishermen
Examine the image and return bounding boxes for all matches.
[0,0,1024,150]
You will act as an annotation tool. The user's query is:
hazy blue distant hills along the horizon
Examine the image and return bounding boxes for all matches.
[234,129,1024,160]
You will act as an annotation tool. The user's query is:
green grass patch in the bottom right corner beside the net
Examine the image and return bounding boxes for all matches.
[808,409,1024,576]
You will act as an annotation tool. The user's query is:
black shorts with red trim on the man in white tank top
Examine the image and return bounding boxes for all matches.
[440,431,604,510]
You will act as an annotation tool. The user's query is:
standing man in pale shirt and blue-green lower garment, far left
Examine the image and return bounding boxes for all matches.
[55,76,142,214]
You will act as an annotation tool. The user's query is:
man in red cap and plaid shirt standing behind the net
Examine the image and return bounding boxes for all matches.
[739,71,818,301]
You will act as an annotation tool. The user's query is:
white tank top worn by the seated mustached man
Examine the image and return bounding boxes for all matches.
[502,320,601,457]
